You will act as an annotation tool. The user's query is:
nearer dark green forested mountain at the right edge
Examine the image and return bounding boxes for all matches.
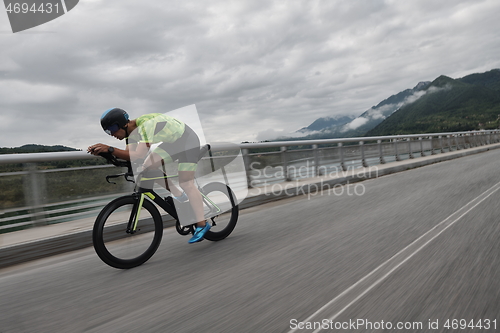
[366,69,500,136]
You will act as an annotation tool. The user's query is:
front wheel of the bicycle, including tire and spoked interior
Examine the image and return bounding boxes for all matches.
[92,196,163,269]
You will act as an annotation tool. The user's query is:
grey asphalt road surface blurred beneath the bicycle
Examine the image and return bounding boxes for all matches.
[0,150,500,333]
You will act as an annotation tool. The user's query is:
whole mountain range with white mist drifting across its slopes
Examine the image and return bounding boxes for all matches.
[279,69,500,140]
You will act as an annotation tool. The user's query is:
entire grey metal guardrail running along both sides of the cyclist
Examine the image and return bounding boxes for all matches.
[0,130,500,233]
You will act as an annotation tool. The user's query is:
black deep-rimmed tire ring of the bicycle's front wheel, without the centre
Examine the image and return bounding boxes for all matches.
[92,195,163,269]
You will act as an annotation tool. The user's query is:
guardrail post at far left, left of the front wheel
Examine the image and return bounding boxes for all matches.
[24,163,46,226]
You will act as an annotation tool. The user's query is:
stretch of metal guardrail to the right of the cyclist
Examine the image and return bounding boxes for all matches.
[237,130,500,187]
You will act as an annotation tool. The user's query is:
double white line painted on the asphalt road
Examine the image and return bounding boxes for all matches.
[288,178,500,333]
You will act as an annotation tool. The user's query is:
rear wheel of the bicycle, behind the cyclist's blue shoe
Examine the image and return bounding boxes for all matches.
[201,183,239,241]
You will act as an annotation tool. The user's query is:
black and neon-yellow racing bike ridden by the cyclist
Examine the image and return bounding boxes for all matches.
[92,145,239,269]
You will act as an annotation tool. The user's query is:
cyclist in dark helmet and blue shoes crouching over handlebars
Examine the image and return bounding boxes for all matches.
[87,108,211,244]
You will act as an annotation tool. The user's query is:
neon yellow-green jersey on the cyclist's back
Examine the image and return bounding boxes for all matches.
[135,113,186,143]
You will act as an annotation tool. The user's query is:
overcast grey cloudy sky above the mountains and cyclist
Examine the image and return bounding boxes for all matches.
[0,0,500,149]
